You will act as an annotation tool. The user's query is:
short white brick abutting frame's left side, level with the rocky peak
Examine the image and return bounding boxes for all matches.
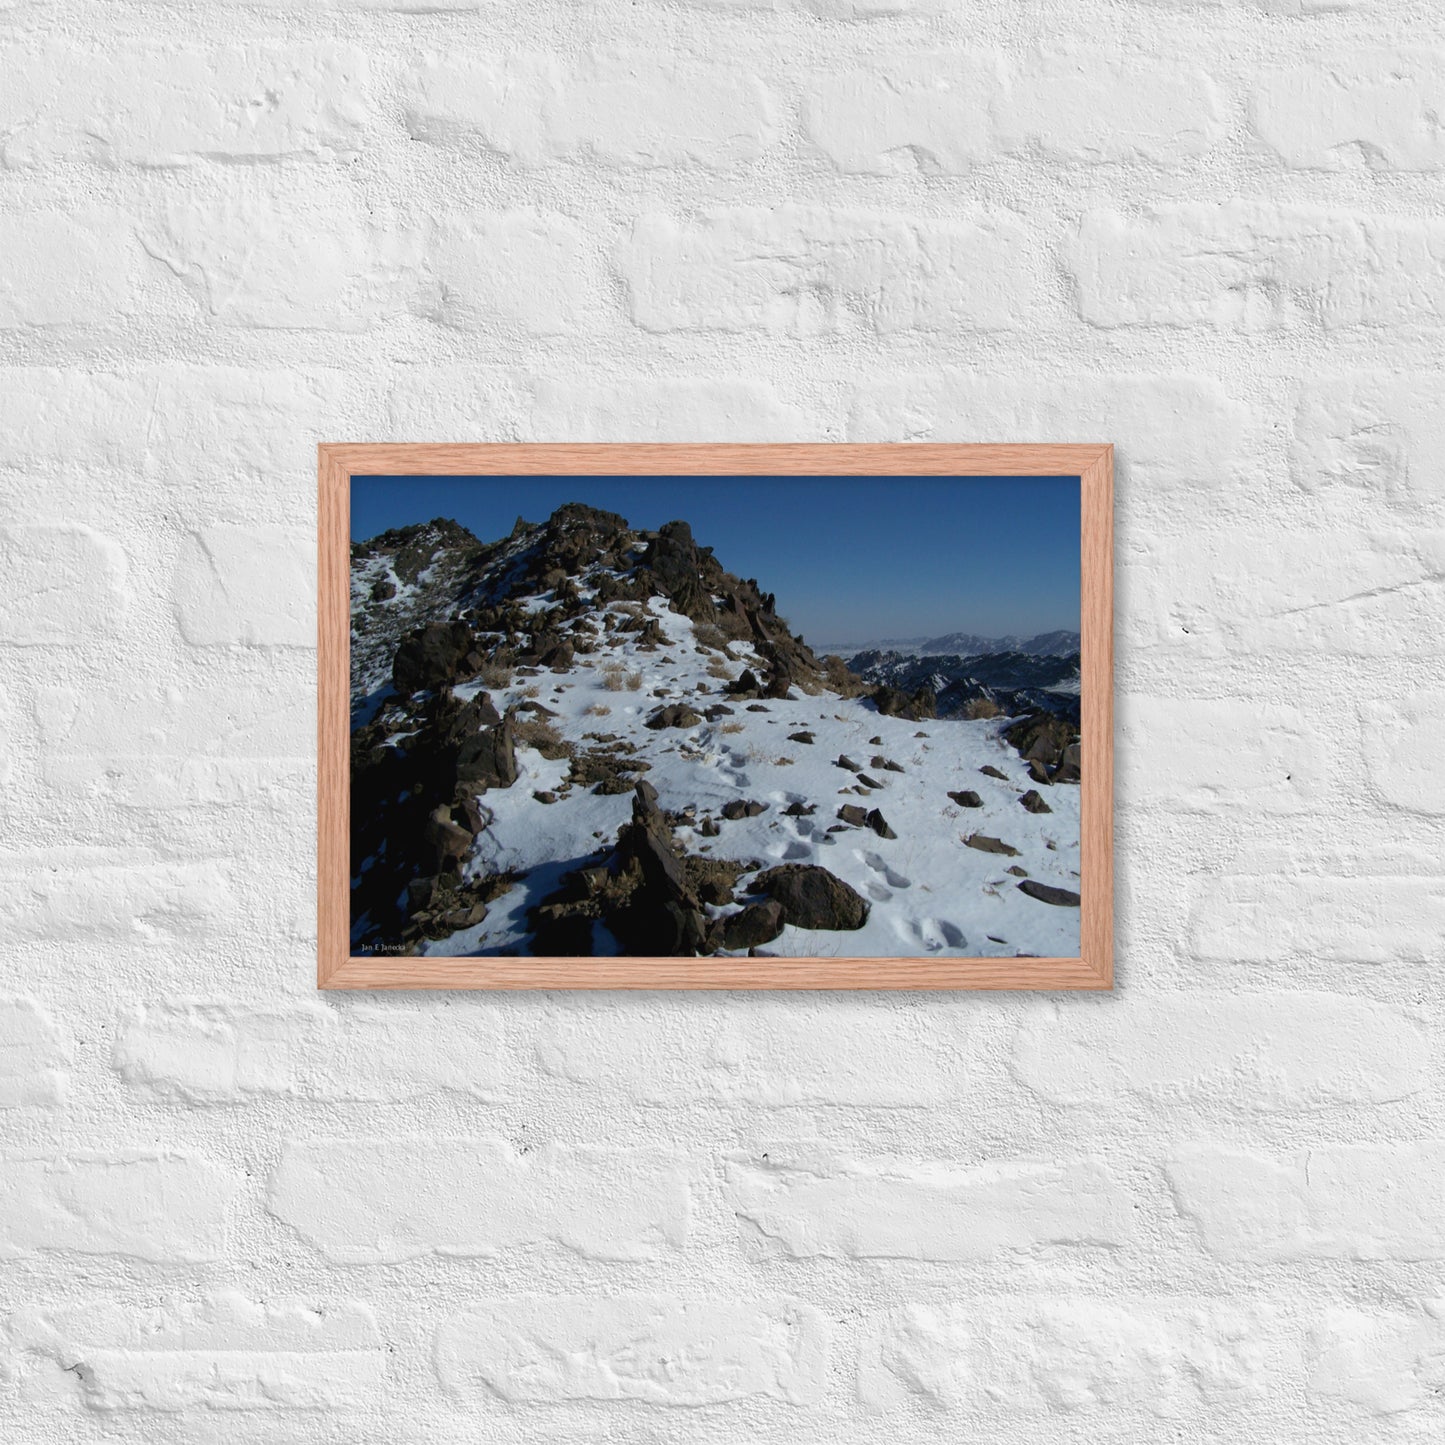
[172,526,316,647]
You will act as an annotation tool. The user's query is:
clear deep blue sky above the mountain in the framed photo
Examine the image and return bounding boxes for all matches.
[351,477,1079,643]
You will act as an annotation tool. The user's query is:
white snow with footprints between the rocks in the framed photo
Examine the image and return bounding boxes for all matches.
[413,598,1079,958]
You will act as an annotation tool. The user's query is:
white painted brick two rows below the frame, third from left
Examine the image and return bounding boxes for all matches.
[728,1146,1133,1260]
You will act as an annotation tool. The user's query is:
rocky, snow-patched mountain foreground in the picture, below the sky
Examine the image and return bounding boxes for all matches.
[351,503,1079,957]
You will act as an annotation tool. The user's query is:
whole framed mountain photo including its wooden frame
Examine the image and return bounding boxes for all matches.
[318,444,1113,988]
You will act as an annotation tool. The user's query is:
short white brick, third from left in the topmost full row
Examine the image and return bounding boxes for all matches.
[802,55,1001,176]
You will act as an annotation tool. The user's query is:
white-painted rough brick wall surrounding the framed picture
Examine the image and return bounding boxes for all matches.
[0,0,1445,1445]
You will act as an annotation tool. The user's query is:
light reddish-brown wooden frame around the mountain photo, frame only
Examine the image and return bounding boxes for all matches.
[316,444,1114,990]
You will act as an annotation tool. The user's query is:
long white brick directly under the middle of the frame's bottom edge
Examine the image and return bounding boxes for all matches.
[538,998,958,1107]
